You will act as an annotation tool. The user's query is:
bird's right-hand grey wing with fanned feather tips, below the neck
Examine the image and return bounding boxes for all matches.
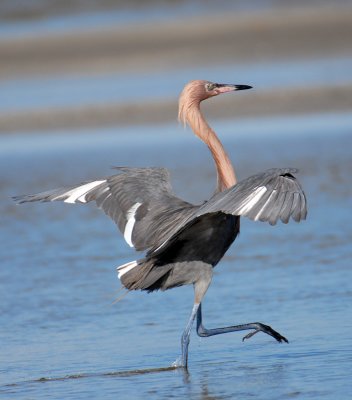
[148,168,307,255]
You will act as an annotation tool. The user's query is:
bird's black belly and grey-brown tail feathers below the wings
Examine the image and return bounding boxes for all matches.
[121,212,240,292]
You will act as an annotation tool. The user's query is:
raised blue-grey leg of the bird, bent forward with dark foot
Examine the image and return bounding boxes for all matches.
[197,304,288,343]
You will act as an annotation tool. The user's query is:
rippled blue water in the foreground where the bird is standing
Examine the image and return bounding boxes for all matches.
[0,114,352,399]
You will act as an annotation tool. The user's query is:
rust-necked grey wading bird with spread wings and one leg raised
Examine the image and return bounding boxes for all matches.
[14,80,307,370]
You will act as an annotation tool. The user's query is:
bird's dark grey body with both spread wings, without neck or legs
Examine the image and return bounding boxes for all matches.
[15,168,307,291]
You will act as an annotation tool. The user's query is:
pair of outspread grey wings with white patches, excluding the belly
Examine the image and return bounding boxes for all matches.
[14,168,307,254]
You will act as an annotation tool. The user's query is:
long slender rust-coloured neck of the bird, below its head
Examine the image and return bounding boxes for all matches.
[186,103,237,192]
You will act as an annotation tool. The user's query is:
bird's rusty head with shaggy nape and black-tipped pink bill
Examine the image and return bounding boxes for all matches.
[178,80,252,123]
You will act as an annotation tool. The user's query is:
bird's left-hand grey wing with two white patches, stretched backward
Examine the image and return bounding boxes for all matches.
[14,167,195,250]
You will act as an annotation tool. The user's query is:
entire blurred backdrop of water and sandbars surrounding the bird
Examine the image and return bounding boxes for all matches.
[0,0,352,400]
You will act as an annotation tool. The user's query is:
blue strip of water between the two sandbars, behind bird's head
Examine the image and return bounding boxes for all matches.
[0,56,352,112]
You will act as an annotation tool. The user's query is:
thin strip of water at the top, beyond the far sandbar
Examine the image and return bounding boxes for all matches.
[0,0,348,40]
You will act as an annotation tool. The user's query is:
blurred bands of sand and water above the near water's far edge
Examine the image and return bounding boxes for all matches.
[0,0,352,133]
